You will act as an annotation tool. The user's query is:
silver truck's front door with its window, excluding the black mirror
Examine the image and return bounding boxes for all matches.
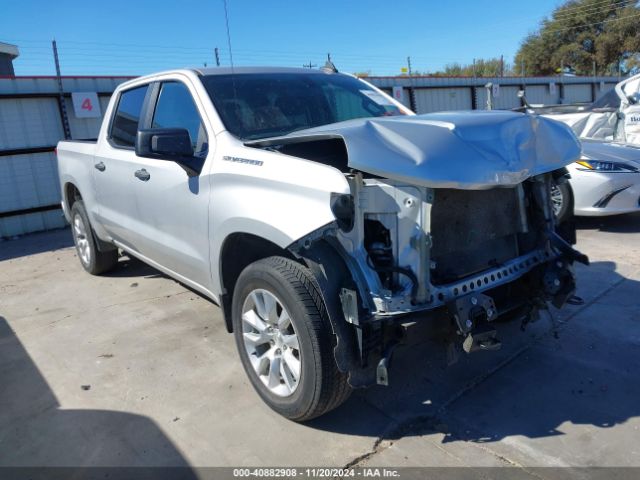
[135,80,214,288]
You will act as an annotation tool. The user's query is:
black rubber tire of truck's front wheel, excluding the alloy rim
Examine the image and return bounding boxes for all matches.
[232,257,351,422]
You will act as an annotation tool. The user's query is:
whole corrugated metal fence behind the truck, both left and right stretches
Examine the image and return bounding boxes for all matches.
[0,76,618,238]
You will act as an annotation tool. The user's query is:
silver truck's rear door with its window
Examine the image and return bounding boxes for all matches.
[92,85,150,251]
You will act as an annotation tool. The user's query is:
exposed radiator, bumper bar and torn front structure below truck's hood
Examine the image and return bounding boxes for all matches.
[288,172,588,387]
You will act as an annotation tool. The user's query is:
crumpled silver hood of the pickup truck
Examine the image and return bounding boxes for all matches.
[248,111,580,189]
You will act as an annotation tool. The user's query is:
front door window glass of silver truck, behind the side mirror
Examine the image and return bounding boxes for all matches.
[152,82,209,157]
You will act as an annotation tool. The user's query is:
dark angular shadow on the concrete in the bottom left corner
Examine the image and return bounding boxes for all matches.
[0,316,197,472]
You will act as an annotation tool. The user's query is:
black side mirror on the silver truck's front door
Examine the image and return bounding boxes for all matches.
[136,128,193,161]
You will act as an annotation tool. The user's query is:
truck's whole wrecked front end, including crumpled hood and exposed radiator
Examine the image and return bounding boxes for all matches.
[245,112,586,387]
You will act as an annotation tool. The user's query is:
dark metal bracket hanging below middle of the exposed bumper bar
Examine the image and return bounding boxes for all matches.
[448,293,502,353]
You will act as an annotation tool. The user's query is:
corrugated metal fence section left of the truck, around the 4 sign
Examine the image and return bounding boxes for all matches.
[0,77,129,238]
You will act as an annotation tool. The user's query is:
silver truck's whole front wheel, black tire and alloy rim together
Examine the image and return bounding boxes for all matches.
[232,257,351,421]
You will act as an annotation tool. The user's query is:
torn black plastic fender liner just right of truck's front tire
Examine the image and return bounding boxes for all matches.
[296,240,377,388]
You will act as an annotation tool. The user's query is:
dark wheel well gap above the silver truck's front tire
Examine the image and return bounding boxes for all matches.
[220,233,295,332]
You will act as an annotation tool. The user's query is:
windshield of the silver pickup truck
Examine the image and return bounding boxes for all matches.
[202,72,404,140]
